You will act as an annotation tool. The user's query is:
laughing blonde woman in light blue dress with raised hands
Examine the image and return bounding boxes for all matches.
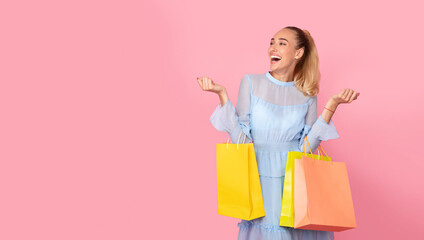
[198,26,359,240]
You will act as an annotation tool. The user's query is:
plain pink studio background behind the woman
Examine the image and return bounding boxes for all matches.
[0,0,424,240]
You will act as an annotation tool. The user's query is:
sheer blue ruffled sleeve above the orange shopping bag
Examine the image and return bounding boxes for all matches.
[299,96,339,153]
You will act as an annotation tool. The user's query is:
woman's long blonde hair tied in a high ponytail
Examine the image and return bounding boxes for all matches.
[285,26,321,96]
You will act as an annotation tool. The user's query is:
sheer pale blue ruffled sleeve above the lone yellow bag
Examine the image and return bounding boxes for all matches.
[209,74,252,143]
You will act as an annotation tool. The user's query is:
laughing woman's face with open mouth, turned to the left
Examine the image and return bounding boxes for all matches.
[268,28,303,72]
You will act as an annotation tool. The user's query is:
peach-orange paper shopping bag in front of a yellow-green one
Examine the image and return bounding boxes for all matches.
[294,141,356,232]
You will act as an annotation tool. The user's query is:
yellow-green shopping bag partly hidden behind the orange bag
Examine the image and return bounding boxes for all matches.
[280,137,331,227]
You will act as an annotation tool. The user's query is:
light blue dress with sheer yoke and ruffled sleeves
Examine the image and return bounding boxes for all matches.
[209,72,339,240]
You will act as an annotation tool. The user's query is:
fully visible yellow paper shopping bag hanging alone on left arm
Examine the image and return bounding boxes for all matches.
[216,131,265,220]
